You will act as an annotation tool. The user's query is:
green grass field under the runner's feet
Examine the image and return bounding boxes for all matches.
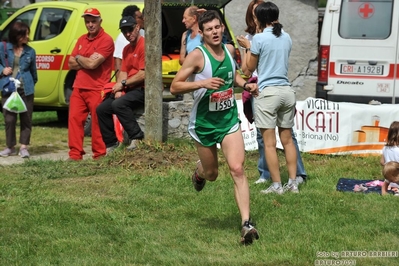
[0,111,399,266]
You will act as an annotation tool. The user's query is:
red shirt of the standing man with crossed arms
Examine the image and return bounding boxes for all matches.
[72,28,114,90]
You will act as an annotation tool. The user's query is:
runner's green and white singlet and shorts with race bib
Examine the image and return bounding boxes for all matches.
[188,44,240,146]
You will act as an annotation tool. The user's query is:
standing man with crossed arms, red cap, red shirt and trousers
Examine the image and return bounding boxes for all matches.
[68,8,114,160]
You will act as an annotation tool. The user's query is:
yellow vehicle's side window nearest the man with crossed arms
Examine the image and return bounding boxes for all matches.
[34,8,71,41]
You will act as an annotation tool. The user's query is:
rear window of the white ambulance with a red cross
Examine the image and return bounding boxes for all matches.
[339,0,393,39]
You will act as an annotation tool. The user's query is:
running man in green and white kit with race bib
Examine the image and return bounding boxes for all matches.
[171,10,259,245]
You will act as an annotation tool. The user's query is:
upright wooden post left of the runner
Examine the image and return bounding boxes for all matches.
[144,0,163,142]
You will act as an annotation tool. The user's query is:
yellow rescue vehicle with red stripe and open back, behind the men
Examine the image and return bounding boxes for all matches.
[0,0,240,119]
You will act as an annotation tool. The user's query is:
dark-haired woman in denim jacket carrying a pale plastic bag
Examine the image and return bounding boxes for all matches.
[0,21,37,158]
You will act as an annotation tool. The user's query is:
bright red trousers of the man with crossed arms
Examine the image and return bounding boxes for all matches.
[68,88,106,160]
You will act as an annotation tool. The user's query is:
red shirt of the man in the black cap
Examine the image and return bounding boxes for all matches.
[121,36,145,87]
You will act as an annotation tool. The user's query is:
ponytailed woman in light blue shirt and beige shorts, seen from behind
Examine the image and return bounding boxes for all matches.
[246,2,299,194]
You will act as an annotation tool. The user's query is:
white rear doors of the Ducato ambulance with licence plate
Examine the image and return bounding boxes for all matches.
[326,0,399,103]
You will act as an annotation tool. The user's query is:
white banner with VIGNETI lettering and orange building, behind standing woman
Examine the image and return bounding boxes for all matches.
[237,98,399,155]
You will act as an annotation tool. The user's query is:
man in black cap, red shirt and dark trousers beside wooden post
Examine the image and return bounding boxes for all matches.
[97,16,145,152]
